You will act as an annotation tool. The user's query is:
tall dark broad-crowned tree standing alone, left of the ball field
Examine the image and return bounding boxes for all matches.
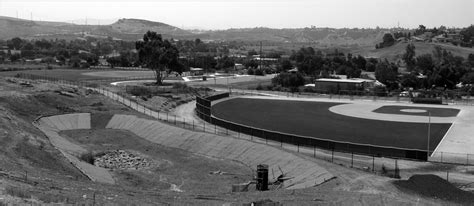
[135,31,183,85]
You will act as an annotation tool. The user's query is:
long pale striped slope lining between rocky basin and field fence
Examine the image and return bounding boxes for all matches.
[106,114,334,189]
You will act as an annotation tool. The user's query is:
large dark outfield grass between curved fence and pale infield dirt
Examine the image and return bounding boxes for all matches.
[212,98,451,150]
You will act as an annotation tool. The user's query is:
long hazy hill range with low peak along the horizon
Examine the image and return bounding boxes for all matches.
[0,17,388,46]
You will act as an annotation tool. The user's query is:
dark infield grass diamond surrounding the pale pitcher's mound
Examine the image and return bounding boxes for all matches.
[373,105,459,117]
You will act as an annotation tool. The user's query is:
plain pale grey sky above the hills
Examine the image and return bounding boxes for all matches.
[0,0,474,29]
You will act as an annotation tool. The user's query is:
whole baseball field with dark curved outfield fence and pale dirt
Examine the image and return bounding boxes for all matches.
[207,96,472,163]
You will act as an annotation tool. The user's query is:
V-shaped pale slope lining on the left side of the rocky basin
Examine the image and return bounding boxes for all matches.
[33,113,115,184]
